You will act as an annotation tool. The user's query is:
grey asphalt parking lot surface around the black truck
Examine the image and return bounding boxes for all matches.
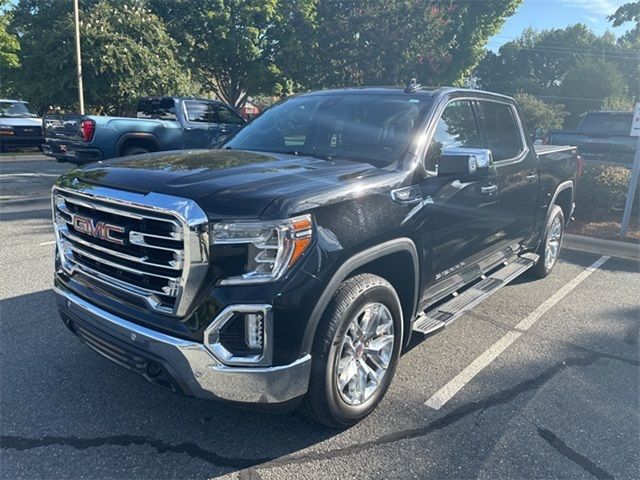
[0,158,640,480]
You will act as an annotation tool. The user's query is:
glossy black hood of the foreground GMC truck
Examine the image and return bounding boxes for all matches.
[63,150,398,219]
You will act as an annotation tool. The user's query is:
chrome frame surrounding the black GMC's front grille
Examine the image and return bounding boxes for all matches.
[52,180,210,317]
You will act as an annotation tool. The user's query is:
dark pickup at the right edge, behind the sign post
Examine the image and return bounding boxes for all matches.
[546,112,638,165]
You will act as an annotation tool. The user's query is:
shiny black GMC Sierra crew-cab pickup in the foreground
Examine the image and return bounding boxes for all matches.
[52,85,580,427]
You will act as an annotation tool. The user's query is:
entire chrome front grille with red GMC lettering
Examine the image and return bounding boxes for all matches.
[53,186,209,316]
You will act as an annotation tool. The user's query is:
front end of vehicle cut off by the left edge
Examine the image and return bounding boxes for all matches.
[0,99,43,152]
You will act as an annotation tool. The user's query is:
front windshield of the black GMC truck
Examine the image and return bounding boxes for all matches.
[224,94,431,166]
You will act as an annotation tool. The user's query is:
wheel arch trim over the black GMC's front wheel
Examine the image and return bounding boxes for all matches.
[302,238,420,355]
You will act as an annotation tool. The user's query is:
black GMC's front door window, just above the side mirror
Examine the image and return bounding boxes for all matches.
[425,100,482,172]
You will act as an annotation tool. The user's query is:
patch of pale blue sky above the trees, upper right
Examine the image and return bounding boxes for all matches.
[487,0,631,51]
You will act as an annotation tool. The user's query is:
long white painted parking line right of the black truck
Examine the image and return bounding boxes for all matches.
[425,255,611,410]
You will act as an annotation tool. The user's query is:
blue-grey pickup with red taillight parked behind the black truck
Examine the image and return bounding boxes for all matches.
[42,97,245,164]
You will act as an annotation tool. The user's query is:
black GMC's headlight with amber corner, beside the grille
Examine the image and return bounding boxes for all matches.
[211,215,313,285]
